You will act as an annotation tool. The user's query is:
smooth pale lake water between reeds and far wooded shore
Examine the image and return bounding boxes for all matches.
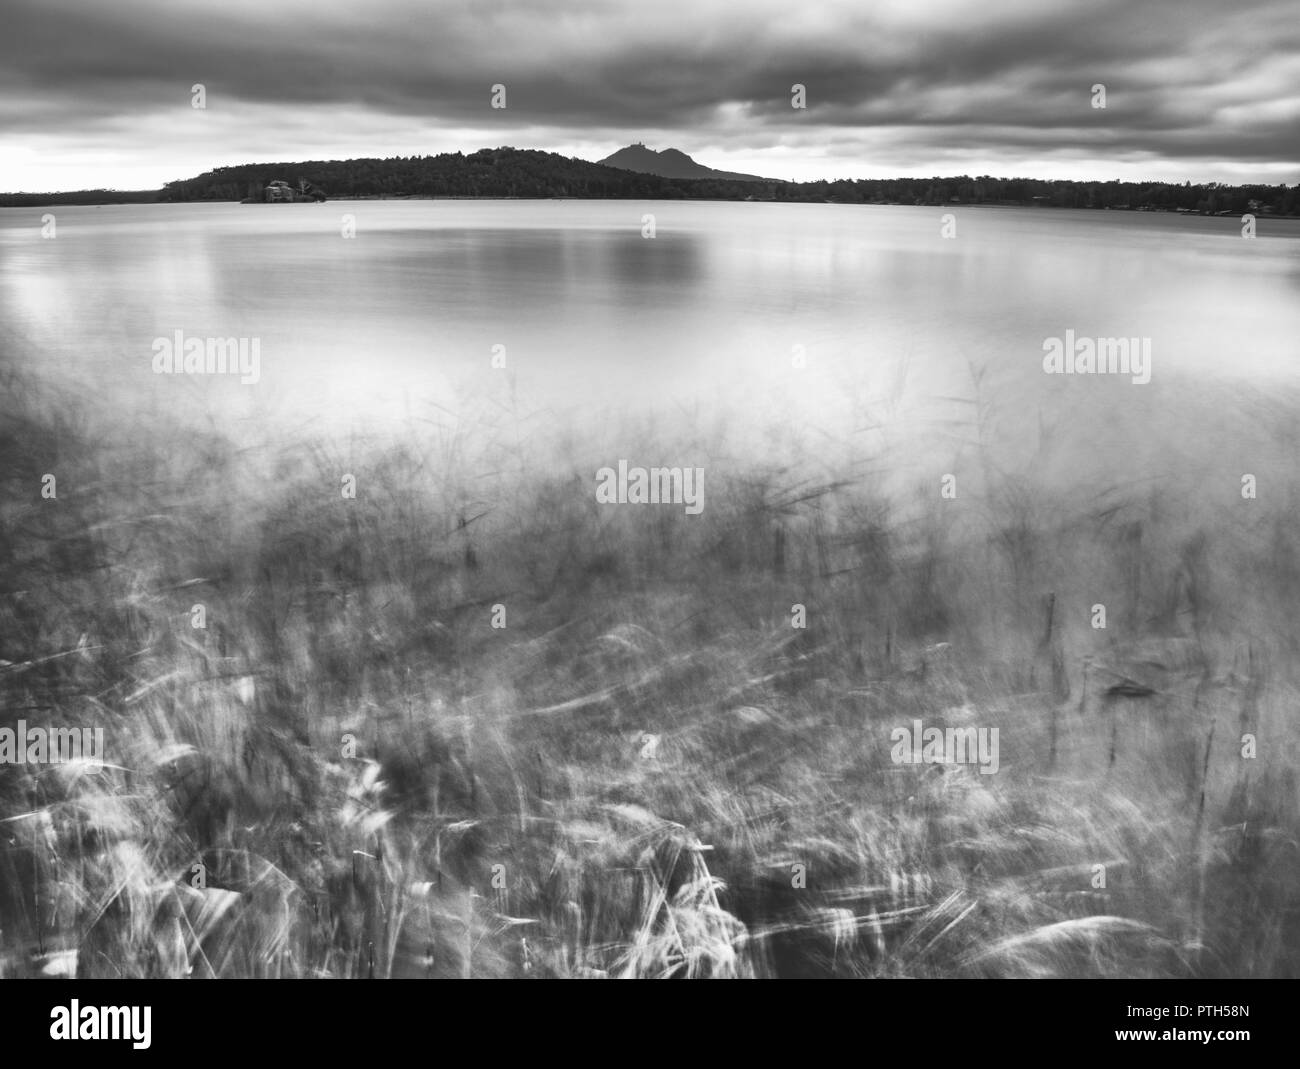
[0,200,1300,473]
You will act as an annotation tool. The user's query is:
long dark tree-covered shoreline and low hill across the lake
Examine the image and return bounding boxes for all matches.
[0,148,1300,215]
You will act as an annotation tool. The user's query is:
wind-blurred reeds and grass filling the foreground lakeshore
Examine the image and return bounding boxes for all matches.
[0,358,1300,978]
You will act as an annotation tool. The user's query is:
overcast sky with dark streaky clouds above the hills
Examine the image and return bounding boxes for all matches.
[0,0,1300,192]
